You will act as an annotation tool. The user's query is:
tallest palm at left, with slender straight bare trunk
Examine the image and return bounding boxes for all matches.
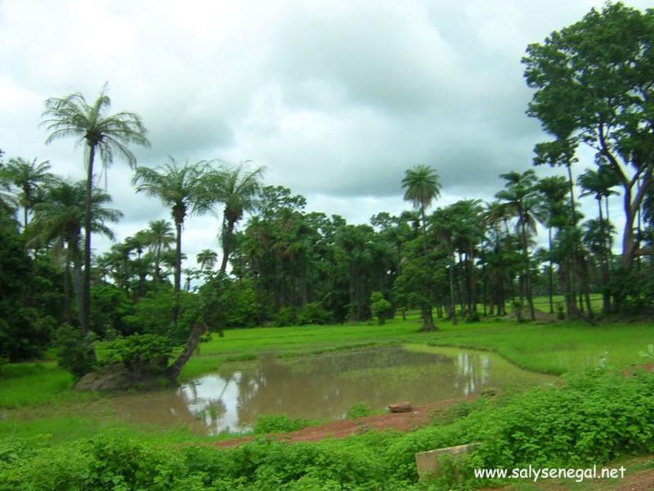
[43,84,150,335]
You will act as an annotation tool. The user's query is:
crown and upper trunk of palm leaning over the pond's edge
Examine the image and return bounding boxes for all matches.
[204,162,266,276]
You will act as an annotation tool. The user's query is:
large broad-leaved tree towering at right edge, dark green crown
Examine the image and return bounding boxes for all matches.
[523,3,654,272]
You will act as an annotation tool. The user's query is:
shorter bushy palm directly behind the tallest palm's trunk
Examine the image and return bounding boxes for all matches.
[26,180,122,323]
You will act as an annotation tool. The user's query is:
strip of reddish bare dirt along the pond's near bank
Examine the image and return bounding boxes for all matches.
[216,398,472,447]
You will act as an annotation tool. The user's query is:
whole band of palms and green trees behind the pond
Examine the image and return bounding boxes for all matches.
[0,3,654,378]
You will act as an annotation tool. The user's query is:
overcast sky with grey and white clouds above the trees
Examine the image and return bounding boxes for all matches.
[0,0,650,268]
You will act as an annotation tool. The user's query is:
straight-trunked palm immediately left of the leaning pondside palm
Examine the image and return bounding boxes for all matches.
[133,157,208,322]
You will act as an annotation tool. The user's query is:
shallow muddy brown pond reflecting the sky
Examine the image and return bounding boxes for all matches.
[106,345,553,434]
